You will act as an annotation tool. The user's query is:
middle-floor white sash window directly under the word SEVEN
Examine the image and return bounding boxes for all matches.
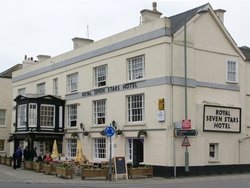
[94,100,106,125]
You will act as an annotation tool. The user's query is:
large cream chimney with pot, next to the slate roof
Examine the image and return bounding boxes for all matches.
[141,2,162,24]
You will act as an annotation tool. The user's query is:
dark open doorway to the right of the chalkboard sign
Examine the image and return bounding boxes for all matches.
[133,139,144,167]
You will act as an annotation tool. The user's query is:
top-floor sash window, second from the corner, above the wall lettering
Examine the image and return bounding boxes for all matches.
[94,65,108,87]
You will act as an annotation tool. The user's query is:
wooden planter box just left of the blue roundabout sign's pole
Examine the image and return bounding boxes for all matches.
[81,168,108,180]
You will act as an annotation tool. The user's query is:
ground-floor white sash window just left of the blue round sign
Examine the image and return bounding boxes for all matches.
[93,138,107,161]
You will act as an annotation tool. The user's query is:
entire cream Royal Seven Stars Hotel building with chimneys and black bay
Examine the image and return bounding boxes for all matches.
[9,3,250,177]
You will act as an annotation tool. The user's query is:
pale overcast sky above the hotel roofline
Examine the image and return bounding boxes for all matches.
[0,0,250,72]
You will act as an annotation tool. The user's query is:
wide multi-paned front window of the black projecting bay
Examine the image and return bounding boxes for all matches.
[40,104,55,128]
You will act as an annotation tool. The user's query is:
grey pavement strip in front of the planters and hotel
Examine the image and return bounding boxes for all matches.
[0,164,250,185]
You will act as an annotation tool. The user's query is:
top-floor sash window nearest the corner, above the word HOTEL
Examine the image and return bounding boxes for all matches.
[128,56,145,81]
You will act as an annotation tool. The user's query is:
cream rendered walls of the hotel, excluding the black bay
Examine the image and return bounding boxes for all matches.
[12,4,250,176]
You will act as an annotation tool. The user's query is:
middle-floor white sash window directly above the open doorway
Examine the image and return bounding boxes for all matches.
[127,94,145,123]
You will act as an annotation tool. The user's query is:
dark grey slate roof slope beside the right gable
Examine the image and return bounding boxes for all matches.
[169,3,209,34]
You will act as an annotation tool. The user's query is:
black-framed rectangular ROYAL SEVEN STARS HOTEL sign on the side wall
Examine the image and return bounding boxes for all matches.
[203,105,241,133]
